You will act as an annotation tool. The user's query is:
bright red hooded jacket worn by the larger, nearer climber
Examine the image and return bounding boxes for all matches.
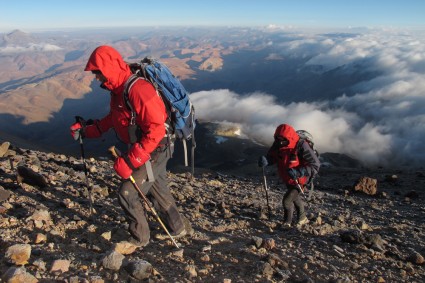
[85,46,167,168]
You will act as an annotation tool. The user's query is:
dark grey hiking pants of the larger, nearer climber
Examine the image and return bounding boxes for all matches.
[118,150,184,242]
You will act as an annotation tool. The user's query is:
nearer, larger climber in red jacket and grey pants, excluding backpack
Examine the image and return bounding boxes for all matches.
[71,46,186,246]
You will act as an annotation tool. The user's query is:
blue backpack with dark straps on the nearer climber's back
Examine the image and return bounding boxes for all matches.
[124,57,196,176]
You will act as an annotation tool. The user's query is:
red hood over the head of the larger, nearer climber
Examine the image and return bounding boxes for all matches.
[84,45,131,94]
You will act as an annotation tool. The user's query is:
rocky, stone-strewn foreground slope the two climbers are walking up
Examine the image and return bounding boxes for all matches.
[0,144,425,282]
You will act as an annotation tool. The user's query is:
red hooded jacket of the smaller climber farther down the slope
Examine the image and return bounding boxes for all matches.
[267,124,311,186]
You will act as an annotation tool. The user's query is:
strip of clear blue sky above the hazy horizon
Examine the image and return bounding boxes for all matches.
[0,0,425,32]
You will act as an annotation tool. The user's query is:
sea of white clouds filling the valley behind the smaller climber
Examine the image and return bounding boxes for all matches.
[191,30,425,169]
